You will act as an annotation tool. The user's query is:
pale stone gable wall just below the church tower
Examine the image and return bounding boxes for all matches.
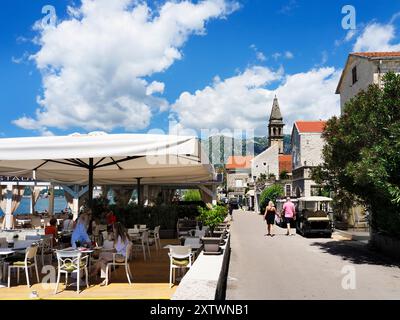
[251,144,279,179]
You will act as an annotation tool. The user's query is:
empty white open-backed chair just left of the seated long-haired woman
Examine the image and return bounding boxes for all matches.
[54,250,89,294]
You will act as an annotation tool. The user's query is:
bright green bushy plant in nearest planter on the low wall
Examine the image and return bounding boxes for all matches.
[198,206,227,253]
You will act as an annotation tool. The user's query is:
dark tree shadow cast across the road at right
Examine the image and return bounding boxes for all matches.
[311,241,400,267]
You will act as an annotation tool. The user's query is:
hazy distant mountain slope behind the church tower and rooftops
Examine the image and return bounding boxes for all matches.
[202,135,291,165]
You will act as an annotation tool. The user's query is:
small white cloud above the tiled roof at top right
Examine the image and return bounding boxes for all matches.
[353,22,400,52]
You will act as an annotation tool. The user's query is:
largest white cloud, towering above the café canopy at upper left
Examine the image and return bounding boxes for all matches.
[14,0,238,131]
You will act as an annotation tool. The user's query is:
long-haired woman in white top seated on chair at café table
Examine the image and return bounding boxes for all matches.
[92,222,131,286]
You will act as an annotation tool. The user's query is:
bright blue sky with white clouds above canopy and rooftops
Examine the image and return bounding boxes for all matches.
[0,0,400,137]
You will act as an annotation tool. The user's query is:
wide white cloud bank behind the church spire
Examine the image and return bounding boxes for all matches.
[172,66,340,136]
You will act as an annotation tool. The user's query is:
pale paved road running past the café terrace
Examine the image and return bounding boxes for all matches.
[226,211,400,300]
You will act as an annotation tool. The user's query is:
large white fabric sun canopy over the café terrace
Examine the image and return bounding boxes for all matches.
[0,134,215,185]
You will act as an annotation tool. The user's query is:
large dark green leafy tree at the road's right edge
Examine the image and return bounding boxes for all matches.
[312,73,400,237]
